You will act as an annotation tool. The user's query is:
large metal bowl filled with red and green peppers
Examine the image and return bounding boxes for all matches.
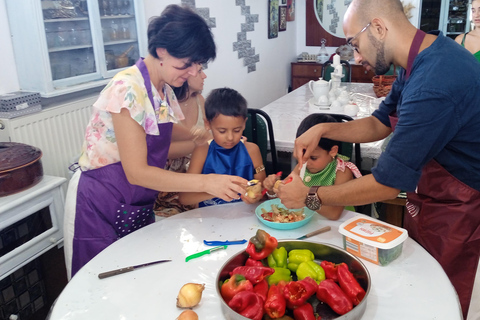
[216,234,371,320]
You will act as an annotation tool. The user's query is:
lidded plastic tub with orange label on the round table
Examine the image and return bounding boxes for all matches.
[338,215,408,266]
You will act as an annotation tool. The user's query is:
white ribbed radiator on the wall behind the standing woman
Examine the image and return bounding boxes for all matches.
[0,96,98,188]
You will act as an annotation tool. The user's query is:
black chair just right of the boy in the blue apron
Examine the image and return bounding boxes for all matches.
[243,108,278,175]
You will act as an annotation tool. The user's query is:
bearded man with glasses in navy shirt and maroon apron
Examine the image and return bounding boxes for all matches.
[274,0,480,319]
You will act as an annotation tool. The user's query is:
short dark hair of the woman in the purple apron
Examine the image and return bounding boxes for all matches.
[147,4,216,64]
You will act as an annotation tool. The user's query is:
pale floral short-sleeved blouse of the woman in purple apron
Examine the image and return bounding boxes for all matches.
[78,66,184,171]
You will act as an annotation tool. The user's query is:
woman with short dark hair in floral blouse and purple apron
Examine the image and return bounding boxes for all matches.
[64,5,247,278]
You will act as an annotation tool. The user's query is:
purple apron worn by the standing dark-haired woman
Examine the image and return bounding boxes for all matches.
[72,59,173,277]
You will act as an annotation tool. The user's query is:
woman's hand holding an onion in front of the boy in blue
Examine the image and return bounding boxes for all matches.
[204,174,248,201]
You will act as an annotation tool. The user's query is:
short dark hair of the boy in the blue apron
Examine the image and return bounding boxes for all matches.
[205,88,248,121]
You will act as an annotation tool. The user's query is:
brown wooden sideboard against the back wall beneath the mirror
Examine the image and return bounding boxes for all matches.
[291,62,375,90]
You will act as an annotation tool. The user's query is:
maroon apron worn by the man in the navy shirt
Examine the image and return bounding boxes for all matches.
[390,29,480,318]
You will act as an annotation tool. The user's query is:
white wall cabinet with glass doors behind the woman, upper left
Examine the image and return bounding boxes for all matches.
[6,0,147,98]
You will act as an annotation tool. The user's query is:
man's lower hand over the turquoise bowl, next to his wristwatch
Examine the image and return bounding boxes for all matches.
[273,172,309,209]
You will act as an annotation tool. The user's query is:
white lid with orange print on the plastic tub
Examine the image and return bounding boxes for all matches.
[338,214,408,249]
